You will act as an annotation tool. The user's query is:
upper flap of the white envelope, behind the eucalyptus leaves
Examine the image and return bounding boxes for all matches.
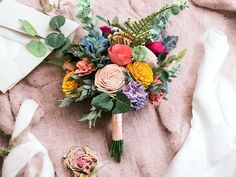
[0,0,78,37]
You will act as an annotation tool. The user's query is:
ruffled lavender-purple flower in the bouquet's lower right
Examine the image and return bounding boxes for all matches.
[122,80,147,110]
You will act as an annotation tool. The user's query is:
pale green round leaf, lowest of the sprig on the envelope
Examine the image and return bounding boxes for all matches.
[26,40,47,58]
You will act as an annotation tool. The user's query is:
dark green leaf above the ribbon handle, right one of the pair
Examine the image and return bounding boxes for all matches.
[112,92,130,114]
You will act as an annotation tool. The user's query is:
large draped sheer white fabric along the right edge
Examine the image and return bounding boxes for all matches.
[165,30,236,177]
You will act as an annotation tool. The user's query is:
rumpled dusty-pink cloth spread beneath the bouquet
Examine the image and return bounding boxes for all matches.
[0,0,236,177]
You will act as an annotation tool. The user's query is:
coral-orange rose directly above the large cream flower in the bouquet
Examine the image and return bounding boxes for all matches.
[108,44,132,66]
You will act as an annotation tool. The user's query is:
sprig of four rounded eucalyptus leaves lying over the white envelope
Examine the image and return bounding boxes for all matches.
[21,16,71,58]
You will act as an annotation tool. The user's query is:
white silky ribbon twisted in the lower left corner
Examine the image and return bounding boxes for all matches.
[2,100,54,177]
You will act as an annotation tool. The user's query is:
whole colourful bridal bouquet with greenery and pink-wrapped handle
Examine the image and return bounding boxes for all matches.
[24,0,187,161]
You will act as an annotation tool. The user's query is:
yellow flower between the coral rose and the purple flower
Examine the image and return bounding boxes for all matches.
[127,61,153,88]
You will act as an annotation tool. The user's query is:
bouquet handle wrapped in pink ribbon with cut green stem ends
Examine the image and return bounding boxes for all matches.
[110,114,123,162]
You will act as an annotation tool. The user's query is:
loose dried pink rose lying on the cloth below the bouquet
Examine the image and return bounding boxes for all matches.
[63,146,98,177]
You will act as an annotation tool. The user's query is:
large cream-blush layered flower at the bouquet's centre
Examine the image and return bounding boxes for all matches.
[94,64,125,94]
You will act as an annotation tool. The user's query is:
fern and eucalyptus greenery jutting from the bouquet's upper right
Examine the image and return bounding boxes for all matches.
[111,2,187,46]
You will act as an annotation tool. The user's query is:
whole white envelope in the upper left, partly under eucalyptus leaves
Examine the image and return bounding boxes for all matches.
[0,0,78,93]
